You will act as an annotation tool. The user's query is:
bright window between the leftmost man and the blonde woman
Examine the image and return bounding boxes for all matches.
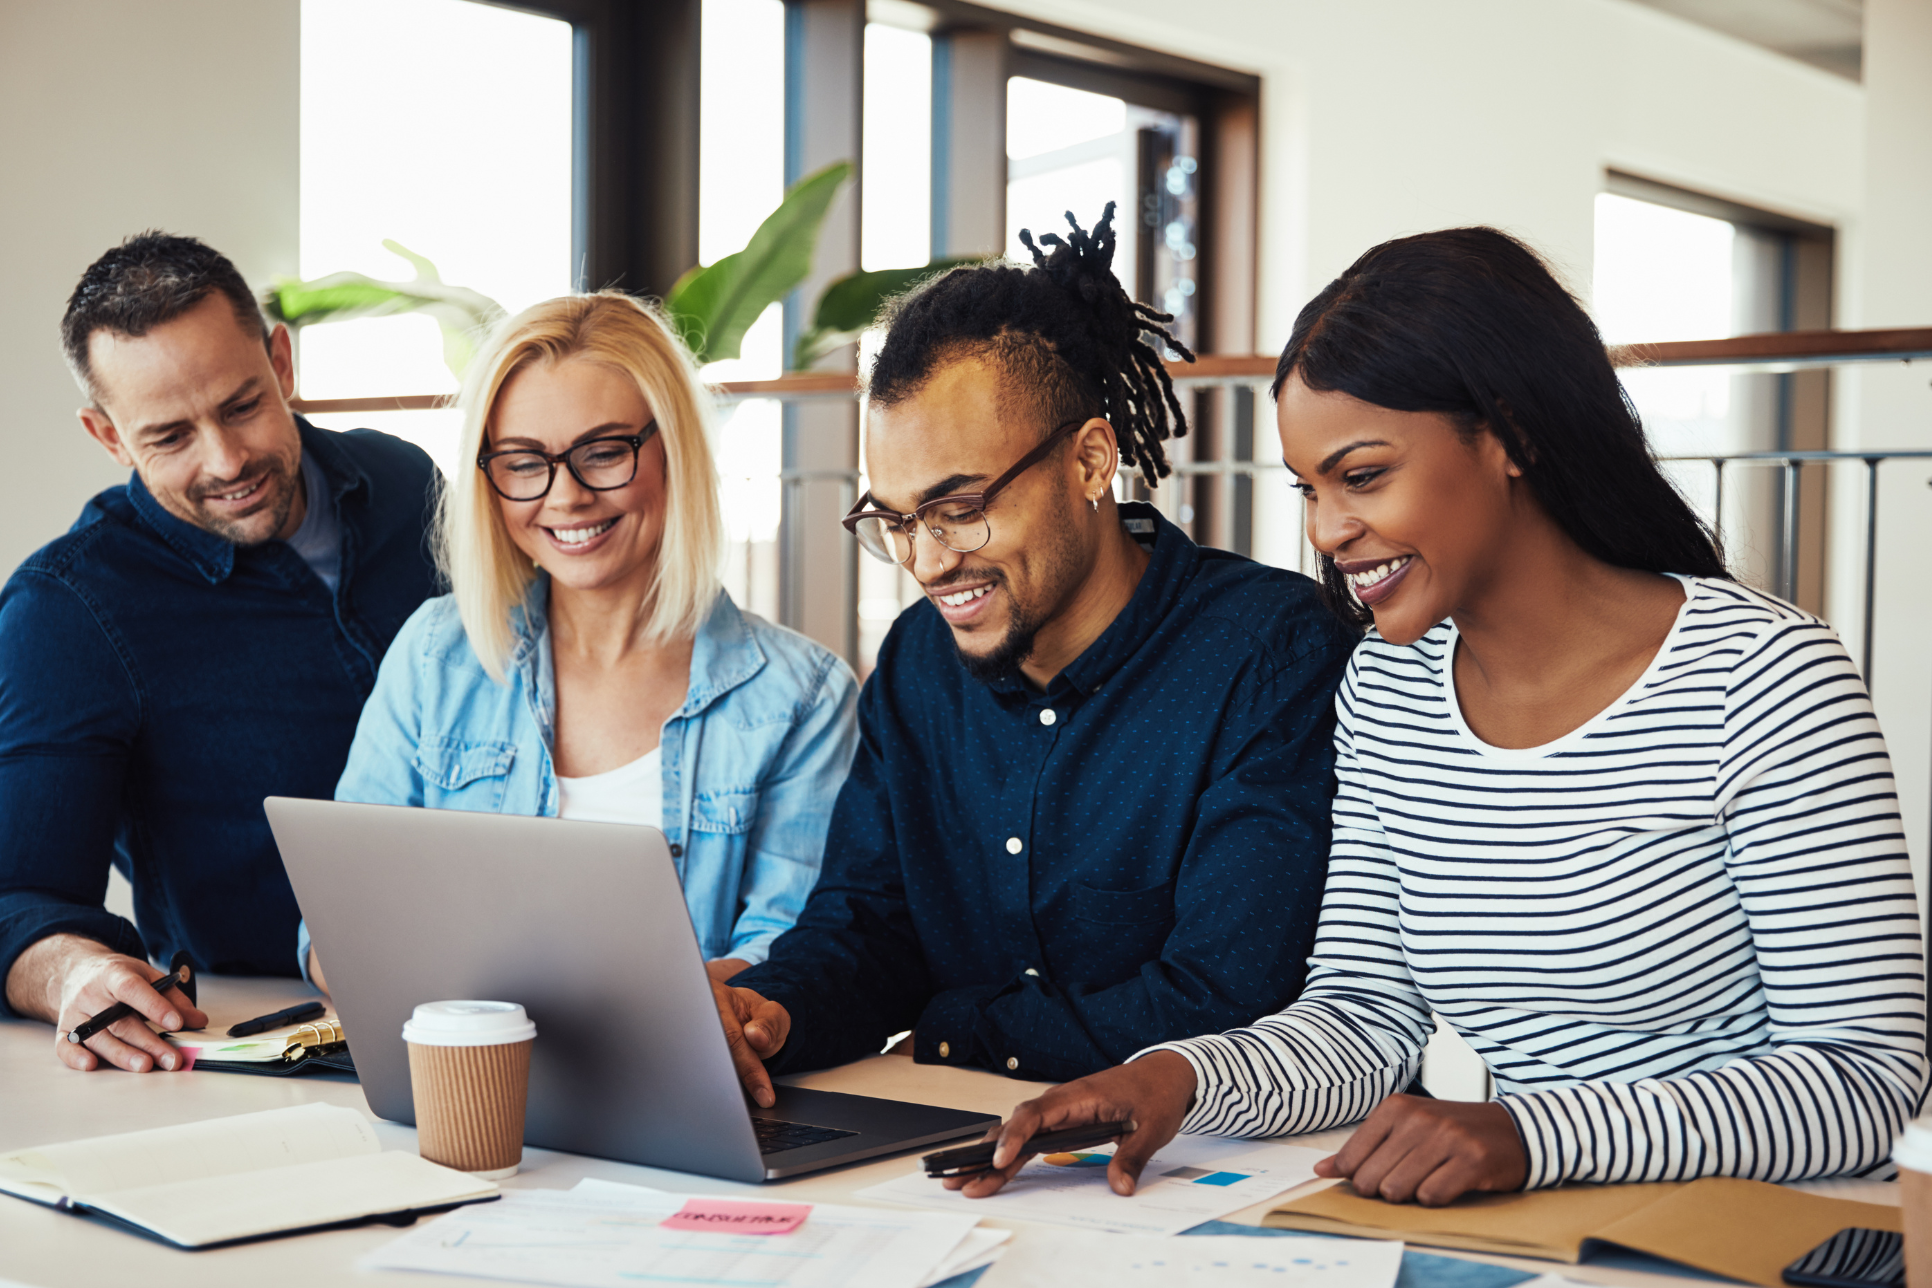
[298,0,572,469]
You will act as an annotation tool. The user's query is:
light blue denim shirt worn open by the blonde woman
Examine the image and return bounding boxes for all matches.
[336,574,858,962]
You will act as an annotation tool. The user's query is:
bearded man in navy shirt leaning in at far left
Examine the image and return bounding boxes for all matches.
[0,232,435,1072]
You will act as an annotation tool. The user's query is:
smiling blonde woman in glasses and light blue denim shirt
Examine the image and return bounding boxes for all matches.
[324,292,858,979]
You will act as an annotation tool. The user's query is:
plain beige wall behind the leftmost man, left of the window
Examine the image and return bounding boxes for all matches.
[0,0,299,575]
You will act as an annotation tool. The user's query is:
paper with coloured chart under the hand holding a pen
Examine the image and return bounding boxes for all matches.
[860,1135,1331,1234]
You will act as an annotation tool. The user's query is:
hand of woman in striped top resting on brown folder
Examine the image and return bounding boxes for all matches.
[1316,1095,1530,1207]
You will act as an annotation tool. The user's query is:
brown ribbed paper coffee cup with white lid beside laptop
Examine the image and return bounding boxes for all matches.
[402,1002,537,1180]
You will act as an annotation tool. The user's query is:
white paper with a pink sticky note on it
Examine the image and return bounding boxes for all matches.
[355,1182,978,1288]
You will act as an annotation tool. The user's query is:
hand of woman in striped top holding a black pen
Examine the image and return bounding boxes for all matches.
[945,1050,1194,1199]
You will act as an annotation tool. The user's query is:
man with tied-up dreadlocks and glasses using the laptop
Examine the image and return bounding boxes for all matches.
[717,205,1354,1105]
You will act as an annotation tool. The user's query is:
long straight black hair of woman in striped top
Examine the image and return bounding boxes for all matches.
[1271,228,1729,626]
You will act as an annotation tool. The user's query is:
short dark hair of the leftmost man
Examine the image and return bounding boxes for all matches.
[60,230,269,404]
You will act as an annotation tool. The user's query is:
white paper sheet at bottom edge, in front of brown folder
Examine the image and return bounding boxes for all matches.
[978,1230,1403,1288]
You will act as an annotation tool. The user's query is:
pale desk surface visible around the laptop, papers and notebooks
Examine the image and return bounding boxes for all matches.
[0,979,1897,1288]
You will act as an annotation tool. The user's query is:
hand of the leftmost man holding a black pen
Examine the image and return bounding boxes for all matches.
[6,935,209,1074]
